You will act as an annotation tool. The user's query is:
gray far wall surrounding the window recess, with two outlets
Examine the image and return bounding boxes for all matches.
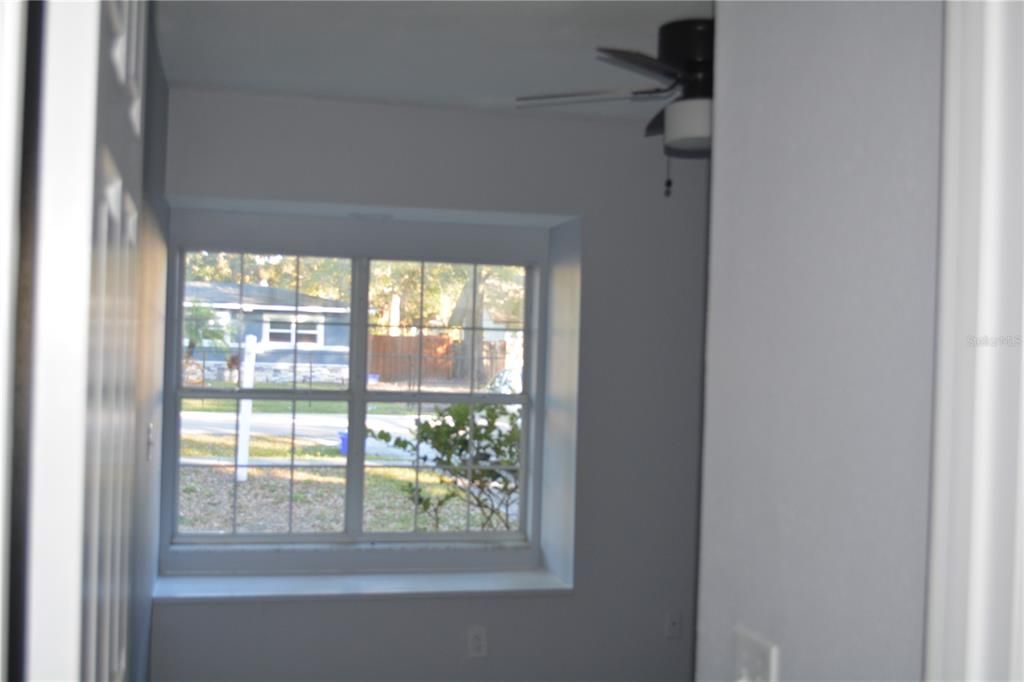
[152,88,708,680]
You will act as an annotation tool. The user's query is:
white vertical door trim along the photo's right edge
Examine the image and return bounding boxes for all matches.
[925,2,1024,680]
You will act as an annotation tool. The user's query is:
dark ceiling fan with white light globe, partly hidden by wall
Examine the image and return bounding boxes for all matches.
[516,19,715,157]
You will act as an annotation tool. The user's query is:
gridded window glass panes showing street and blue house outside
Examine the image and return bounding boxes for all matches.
[170,250,532,546]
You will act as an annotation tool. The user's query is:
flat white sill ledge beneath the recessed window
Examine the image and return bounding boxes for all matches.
[153,569,572,603]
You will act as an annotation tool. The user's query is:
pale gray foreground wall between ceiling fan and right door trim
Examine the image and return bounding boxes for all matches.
[698,2,942,680]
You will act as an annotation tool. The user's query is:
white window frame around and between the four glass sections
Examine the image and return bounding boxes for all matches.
[160,211,574,576]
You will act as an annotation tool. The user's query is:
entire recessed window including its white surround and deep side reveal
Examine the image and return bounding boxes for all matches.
[160,208,583,594]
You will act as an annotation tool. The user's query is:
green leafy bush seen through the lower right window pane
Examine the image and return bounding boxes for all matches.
[371,404,522,530]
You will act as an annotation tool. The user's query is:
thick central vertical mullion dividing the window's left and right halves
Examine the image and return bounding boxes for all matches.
[345,258,370,537]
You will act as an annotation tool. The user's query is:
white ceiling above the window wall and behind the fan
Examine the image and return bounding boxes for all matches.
[157,1,713,123]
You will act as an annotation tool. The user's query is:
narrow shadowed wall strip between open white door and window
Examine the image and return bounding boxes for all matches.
[128,19,170,680]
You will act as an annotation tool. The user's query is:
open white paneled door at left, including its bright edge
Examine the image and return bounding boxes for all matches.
[23,0,145,680]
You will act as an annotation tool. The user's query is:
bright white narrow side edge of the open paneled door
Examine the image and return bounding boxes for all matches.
[22,2,102,680]
